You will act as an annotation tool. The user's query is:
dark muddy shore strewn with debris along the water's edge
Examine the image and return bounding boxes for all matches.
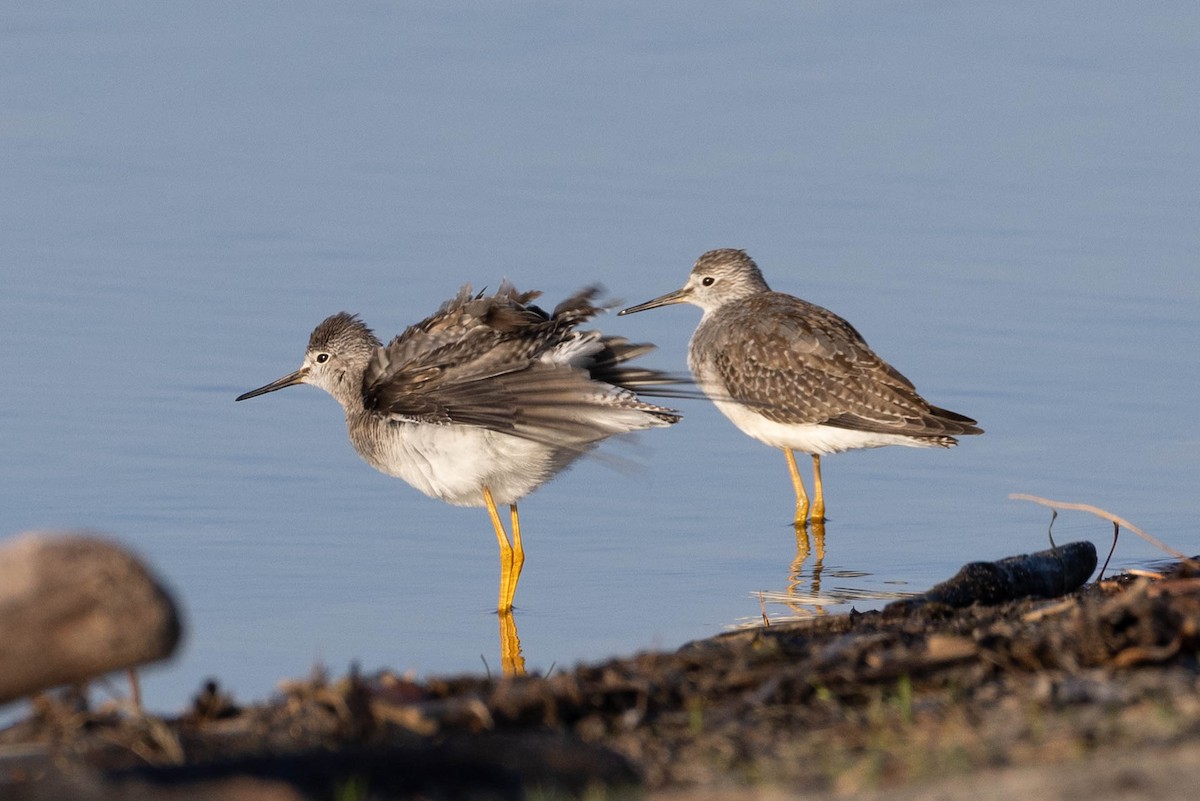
[0,546,1200,801]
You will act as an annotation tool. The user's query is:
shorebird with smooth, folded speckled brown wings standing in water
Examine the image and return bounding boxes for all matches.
[620,248,983,526]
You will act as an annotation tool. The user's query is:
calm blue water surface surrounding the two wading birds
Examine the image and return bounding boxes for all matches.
[0,1,1200,710]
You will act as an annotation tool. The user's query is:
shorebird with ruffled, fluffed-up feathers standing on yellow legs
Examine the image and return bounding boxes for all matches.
[238,282,680,614]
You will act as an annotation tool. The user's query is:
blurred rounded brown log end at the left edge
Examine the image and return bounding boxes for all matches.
[0,532,181,703]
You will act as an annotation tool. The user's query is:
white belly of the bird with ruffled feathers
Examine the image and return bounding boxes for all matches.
[355,423,582,506]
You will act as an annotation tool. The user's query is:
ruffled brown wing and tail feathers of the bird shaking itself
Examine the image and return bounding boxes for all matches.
[362,283,678,445]
